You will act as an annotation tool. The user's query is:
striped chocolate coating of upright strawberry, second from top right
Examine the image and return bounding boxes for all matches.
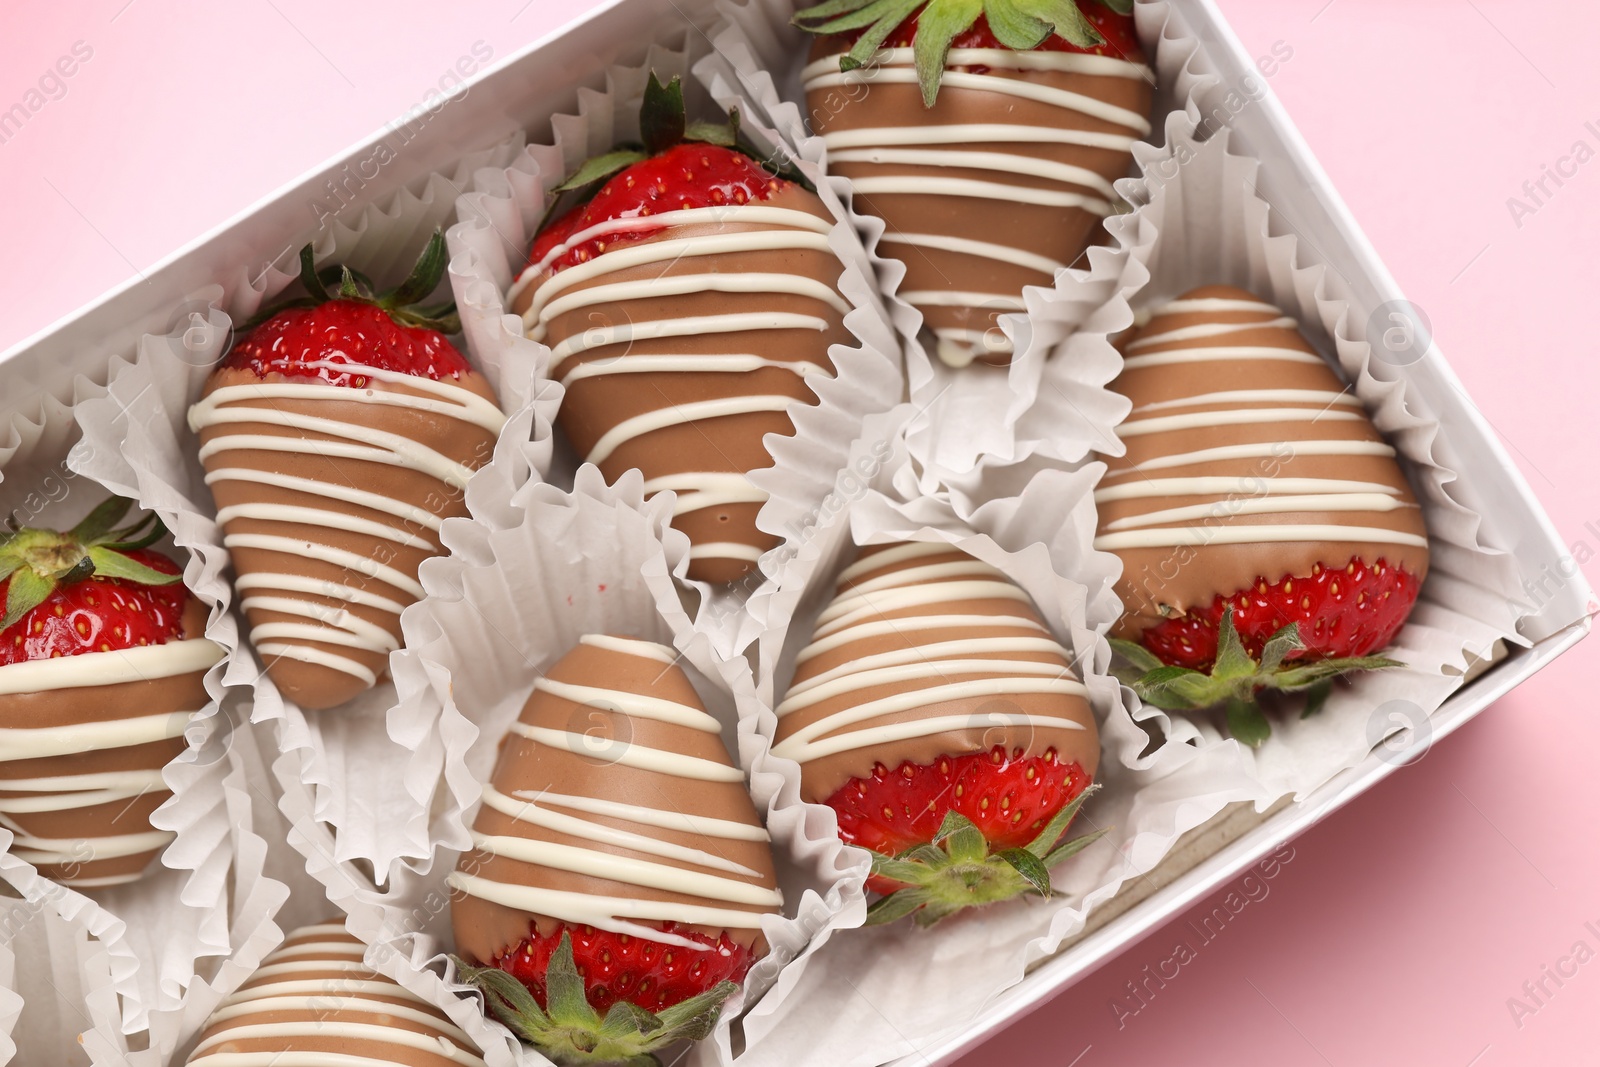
[510,186,850,582]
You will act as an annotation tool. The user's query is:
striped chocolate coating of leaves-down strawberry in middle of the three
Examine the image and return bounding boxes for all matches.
[774,544,1099,803]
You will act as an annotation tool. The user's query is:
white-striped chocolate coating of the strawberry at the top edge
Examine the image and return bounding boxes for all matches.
[802,38,1154,366]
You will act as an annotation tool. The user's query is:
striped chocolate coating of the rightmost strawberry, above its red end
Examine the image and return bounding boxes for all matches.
[1094,286,1427,635]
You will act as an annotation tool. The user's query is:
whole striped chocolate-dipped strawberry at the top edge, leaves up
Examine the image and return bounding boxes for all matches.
[794,0,1154,366]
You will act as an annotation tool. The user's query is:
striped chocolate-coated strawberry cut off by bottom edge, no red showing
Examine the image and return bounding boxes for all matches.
[186,921,483,1067]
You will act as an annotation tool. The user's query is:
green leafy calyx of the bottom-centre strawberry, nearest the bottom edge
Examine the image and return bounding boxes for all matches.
[451,933,739,1067]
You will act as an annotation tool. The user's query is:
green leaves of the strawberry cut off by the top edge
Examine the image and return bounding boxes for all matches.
[794,0,1134,107]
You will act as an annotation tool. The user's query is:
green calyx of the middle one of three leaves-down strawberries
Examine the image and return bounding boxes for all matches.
[867,785,1106,926]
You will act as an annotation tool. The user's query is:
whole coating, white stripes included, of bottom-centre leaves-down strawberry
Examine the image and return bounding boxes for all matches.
[450,635,782,963]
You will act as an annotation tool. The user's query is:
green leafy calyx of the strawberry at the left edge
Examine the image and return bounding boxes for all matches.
[0,496,182,630]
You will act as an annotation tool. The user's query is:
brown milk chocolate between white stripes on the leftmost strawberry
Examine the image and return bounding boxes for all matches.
[0,597,206,888]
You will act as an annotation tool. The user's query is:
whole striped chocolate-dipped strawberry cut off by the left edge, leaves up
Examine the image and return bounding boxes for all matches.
[0,498,222,888]
